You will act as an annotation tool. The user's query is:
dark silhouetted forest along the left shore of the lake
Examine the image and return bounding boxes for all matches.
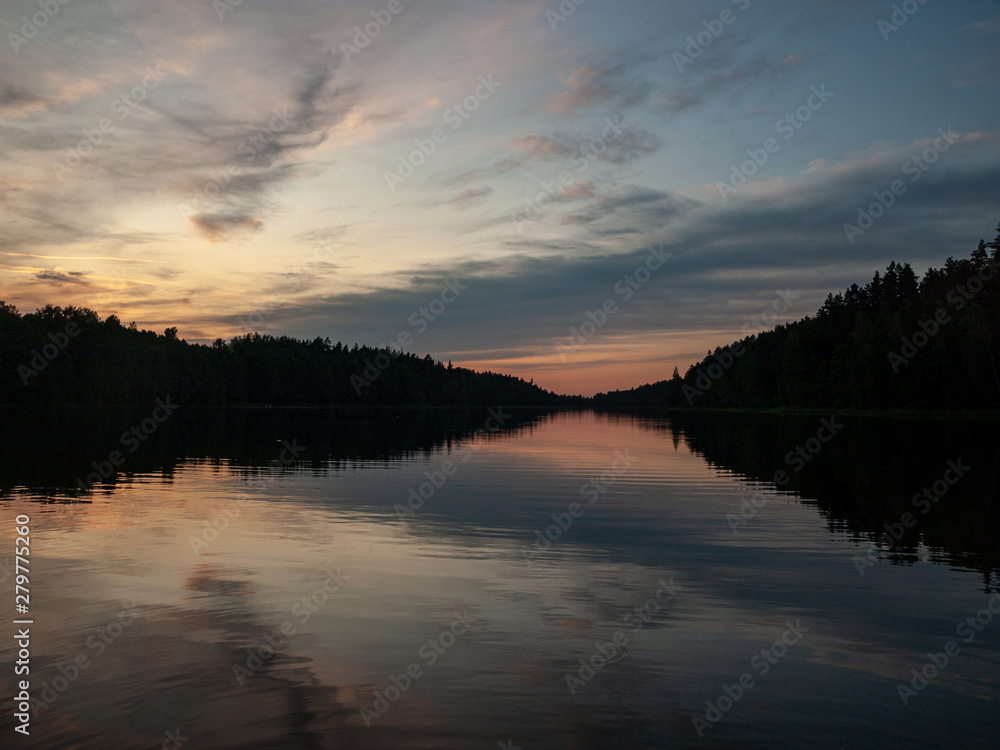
[0,301,584,407]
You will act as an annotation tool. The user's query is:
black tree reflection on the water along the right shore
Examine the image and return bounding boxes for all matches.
[663,412,1000,592]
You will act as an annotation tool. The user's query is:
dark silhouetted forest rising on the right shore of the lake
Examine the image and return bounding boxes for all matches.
[594,226,1000,411]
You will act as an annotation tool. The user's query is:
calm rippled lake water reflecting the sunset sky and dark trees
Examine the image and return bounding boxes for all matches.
[0,407,1000,750]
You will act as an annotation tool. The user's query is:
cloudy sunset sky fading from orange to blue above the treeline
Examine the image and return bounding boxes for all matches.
[0,0,1000,395]
